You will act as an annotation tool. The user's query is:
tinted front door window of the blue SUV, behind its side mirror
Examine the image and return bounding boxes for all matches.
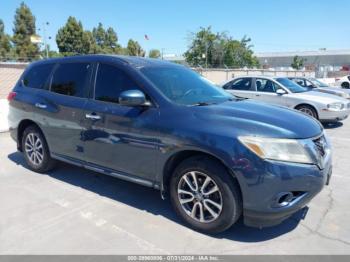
[95,64,139,103]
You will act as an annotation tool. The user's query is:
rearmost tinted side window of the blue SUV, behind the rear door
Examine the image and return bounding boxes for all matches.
[23,64,54,89]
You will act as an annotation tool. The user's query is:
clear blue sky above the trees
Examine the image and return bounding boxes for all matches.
[0,0,350,54]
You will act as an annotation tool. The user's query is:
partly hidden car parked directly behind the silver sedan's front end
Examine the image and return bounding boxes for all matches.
[288,77,350,100]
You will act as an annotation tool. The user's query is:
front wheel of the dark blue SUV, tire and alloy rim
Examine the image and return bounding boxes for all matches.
[170,156,242,234]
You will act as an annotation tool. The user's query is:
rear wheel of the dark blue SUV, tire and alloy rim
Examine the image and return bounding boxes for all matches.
[22,126,55,173]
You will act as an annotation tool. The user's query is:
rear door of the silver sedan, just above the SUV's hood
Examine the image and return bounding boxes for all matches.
[223,77,255,98]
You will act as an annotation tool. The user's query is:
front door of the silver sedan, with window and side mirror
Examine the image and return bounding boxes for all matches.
[254,78,287,106]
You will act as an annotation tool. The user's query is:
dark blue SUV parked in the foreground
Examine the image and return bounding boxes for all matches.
[8,55,331,233]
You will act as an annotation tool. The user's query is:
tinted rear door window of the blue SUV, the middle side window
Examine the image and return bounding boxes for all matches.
[51,63,90,97]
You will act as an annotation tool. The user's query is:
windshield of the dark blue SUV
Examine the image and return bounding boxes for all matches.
[141,66,233,105]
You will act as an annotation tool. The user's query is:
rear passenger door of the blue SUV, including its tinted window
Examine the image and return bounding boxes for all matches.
[36,62,92,159]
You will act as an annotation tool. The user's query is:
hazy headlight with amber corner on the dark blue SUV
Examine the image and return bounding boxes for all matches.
[238,136,314,164]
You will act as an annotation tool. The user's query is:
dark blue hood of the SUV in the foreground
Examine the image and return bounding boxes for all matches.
[193,100,323,139]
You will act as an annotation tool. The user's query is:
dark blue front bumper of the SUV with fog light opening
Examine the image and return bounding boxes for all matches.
[230,138,332,228]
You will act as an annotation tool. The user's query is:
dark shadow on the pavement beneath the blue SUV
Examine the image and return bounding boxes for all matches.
[8,152,306,242]
